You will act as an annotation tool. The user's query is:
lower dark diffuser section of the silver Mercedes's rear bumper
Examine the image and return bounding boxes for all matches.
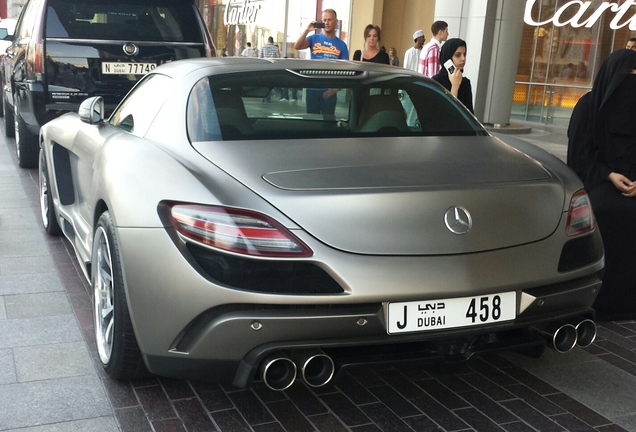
[145,275,601,387]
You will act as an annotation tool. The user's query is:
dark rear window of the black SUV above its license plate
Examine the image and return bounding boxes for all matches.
[46,0,202,43]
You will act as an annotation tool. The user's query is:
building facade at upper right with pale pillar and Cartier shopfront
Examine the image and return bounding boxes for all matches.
[352,0,636,125]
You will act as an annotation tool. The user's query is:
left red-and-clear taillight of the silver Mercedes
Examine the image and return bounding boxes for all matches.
[170,204,313,258]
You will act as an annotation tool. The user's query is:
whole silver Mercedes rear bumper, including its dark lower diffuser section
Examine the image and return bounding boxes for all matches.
[112,228,603,386]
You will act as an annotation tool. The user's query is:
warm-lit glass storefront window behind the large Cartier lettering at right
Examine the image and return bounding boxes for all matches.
[511,0,636,125]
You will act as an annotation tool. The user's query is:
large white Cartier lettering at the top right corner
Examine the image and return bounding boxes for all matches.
[523,0,636,31]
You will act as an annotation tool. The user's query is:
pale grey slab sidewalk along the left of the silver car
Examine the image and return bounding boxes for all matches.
[0,135,119,432]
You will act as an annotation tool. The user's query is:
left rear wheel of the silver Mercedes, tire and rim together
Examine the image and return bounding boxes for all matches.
[91,211,148,379]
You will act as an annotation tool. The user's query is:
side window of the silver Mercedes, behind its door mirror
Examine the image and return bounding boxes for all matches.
[109,74,172,137]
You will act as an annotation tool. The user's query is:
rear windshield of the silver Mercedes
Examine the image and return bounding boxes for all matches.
[187,70,487,142]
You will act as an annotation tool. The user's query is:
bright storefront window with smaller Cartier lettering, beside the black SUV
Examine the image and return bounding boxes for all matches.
[199,0,351,58]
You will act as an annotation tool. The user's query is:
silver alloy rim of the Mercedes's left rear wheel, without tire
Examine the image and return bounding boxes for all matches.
[92,226,115,365]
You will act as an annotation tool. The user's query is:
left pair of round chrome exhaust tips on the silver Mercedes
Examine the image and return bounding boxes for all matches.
[259,350,336,391]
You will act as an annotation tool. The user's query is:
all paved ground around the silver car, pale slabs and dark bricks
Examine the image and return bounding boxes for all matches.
[0,124,636,432]
